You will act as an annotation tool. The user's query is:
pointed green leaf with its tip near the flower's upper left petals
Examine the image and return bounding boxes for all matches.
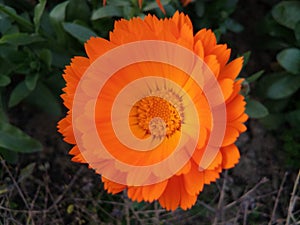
[63,23,98,43]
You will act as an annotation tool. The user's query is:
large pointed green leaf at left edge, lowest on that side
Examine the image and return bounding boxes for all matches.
[0,122,43,153]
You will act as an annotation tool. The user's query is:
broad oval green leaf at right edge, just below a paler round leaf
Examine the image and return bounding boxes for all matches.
[264,74,300,99]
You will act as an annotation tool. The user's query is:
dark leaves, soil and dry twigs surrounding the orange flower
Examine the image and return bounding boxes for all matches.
[0,0,300,225]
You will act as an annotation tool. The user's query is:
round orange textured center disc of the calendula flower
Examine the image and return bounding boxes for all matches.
[131,96,182,138]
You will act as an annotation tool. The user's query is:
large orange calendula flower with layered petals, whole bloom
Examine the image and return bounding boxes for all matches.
[58,12,248,210]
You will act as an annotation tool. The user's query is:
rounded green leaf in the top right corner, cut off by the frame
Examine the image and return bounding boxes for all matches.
[272,1,300,29]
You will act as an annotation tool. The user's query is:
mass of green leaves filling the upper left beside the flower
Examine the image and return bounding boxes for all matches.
[0,0,172,162]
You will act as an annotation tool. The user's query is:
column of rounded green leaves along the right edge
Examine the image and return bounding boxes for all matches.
[257,1,300,169]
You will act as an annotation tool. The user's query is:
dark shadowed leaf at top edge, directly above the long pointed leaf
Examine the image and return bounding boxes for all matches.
[66,0,91,23]
